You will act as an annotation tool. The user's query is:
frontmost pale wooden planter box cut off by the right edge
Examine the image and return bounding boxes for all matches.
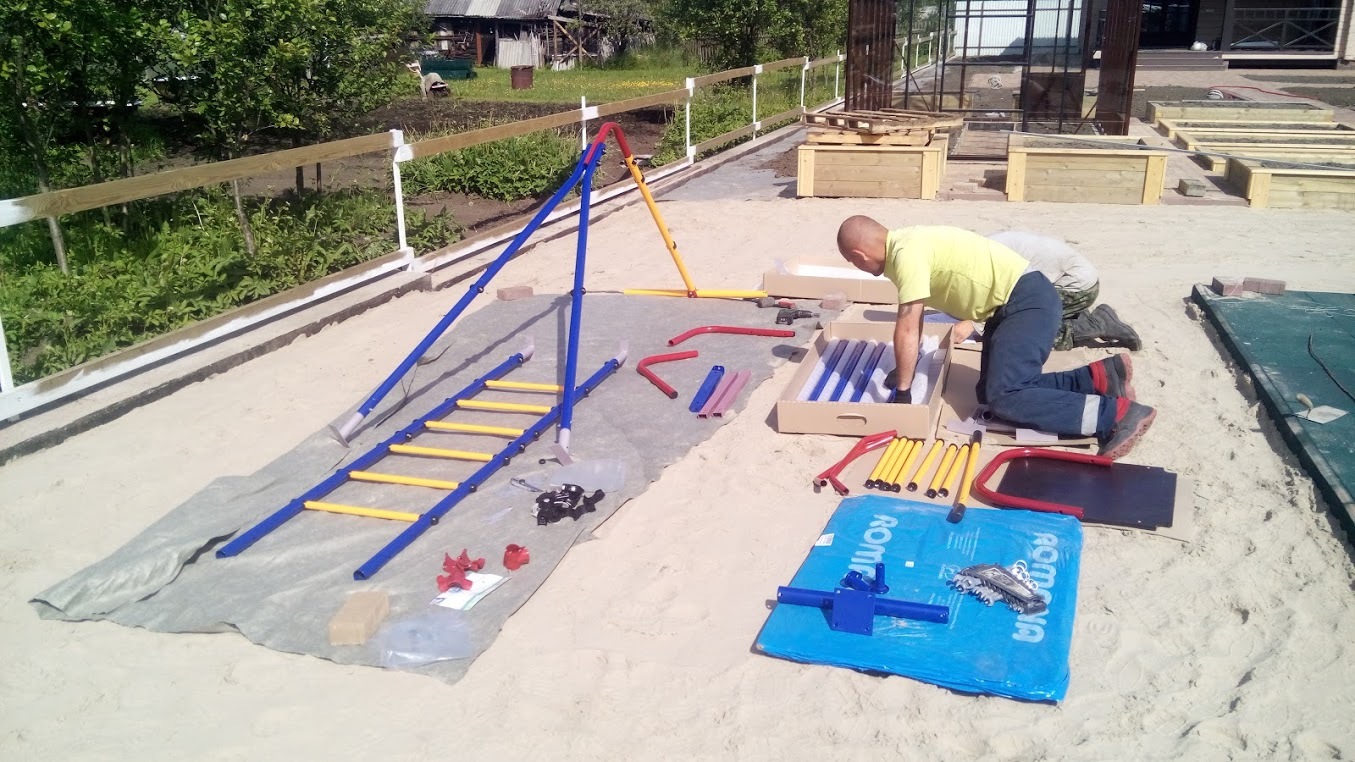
[1225,157,1355,210]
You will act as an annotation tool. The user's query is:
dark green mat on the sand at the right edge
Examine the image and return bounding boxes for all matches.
[1195,286,1355,532]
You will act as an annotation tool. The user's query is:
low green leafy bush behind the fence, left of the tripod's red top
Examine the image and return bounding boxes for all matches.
[401,132,579,201]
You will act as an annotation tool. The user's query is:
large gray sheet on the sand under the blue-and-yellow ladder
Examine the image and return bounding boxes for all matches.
[31,294,831,682]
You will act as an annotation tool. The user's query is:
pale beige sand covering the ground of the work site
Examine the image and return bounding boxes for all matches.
[0,154,1355,761]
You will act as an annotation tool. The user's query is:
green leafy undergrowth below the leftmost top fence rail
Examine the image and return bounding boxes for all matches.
[0,190,458,382]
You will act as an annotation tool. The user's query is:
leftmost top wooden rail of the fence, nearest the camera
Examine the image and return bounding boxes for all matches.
[0,132,394,225]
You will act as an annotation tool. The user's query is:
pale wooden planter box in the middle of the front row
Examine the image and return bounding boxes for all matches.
[1007,134,1167,203]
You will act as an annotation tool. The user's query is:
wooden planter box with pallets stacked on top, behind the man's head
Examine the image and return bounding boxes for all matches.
[797,140,947,198]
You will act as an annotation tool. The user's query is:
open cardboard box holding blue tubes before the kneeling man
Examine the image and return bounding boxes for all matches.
[776,320,951,439]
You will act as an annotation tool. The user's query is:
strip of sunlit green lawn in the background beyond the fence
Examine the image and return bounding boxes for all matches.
[447,65,702,106]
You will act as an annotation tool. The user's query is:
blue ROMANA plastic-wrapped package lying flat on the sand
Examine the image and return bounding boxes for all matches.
[757,495,1083,701]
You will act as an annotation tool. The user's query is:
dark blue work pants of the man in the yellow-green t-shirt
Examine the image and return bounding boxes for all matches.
[977,273,1115,437]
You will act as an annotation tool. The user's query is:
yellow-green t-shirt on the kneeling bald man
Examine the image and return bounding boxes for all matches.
[885,225,1028,320]
